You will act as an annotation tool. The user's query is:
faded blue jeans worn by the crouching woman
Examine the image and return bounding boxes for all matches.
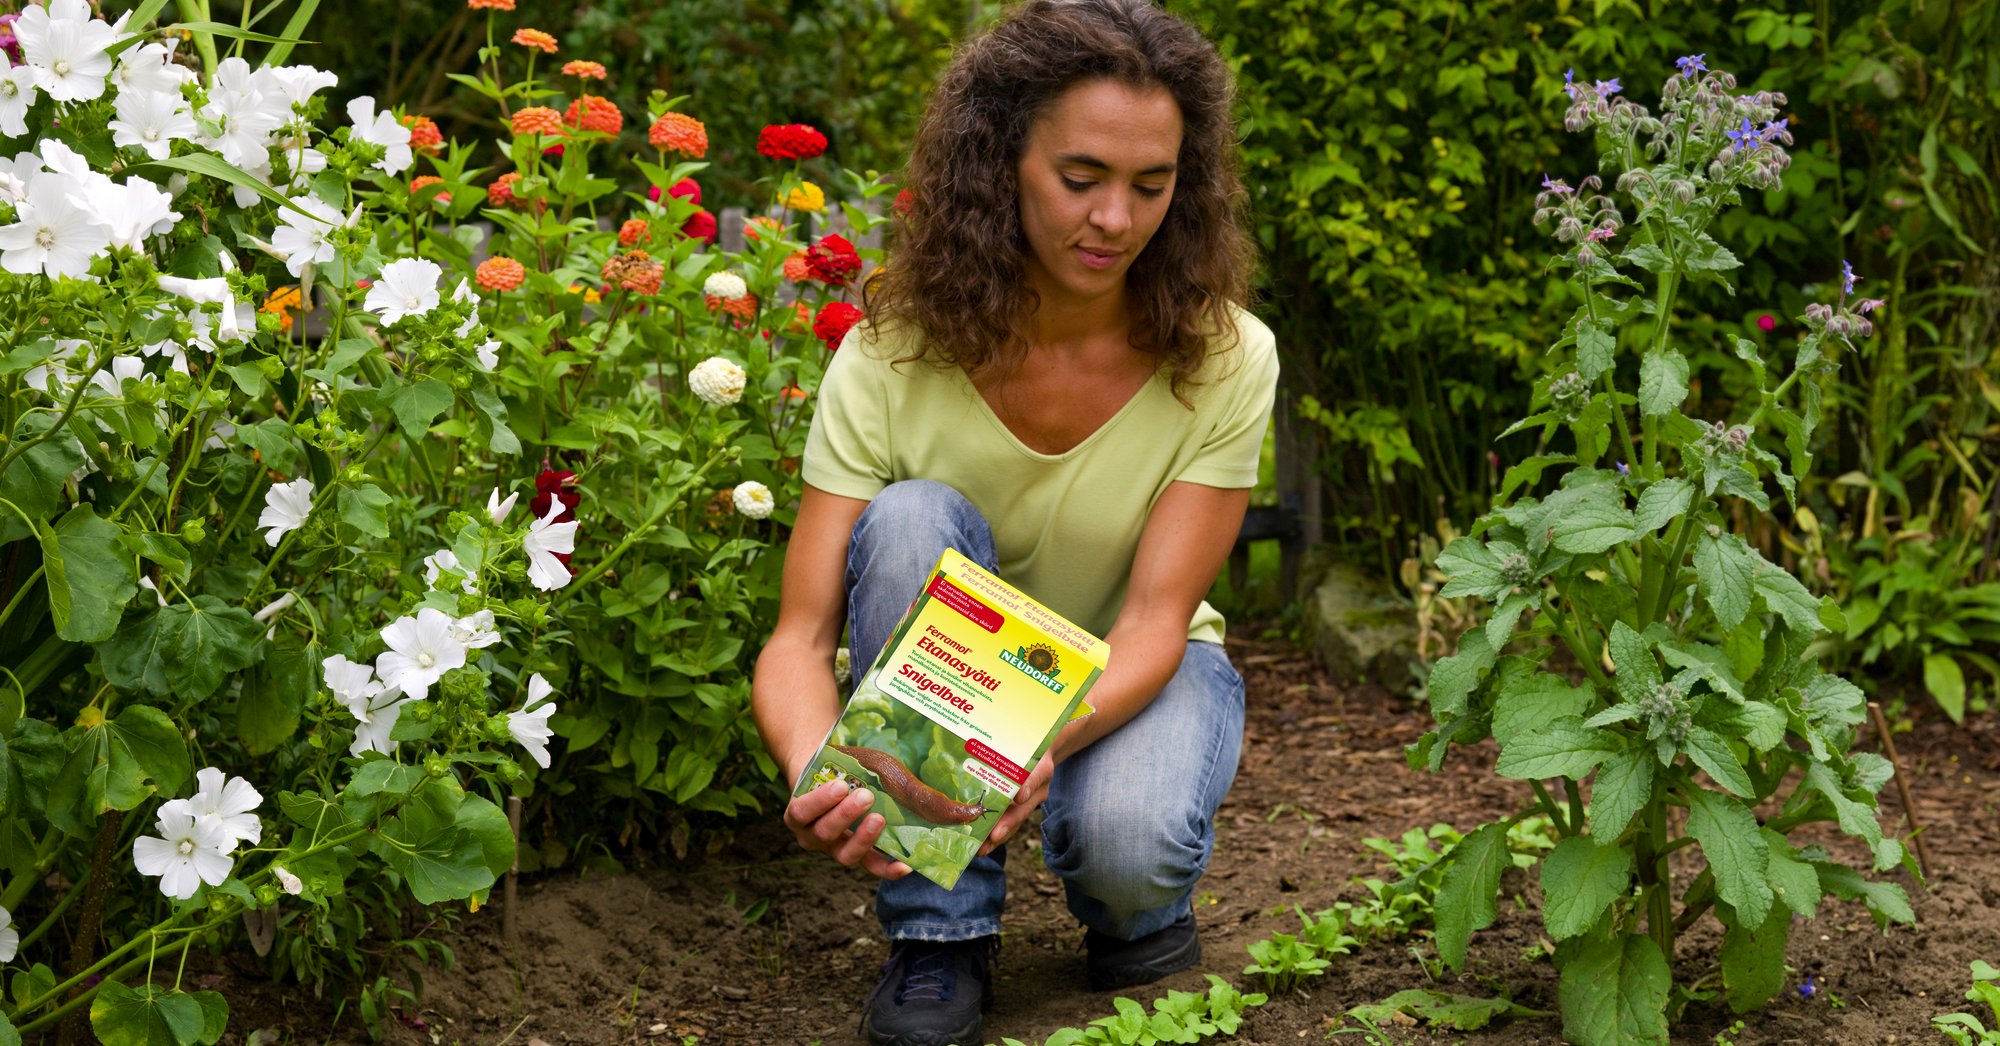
[846,480,1244,940]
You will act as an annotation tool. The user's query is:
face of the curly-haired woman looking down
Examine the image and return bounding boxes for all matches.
[1018,80,1182,306]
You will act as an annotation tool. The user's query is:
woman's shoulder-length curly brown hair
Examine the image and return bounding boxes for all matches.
[864,0,1256,396]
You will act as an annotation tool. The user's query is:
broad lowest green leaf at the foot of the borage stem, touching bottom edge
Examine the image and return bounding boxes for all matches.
[1558,934,1672,1046]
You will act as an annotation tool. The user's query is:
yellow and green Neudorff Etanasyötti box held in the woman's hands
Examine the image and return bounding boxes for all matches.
[794,550,1110,890]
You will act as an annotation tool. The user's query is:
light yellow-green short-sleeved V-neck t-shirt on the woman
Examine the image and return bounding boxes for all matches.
[804,312,1278,642]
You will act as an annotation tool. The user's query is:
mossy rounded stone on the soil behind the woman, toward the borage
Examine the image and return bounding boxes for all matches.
[1306,564,1418,694]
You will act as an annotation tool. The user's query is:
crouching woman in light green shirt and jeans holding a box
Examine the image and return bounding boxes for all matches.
[752,0,1278,1046]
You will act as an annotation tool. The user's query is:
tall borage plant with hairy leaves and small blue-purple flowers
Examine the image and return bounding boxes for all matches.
[1410,56,1912,1046]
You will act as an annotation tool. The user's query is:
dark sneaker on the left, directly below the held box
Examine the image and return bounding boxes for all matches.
[862,936,1000,1046]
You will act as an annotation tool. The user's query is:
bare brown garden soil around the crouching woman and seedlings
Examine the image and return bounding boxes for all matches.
[220,640,2000,1046]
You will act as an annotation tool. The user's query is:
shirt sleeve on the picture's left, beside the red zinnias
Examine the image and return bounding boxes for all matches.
[802,328,892,500]
